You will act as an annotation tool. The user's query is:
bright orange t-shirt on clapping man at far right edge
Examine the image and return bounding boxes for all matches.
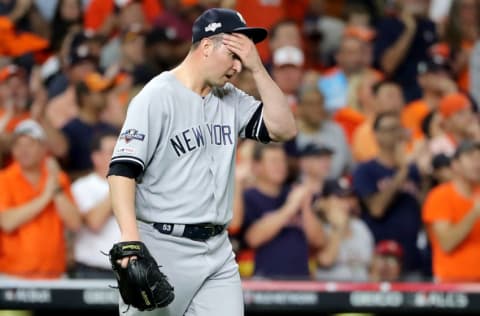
[422,182,480,282]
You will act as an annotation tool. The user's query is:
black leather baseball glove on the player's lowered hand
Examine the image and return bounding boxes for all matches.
[109,241,175,311]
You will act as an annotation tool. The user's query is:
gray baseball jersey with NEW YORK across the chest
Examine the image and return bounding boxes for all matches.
[111,72,264,224]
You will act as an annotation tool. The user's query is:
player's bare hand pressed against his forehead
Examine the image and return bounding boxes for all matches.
[223,33,263,72]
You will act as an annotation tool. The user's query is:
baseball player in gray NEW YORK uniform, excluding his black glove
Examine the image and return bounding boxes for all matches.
[108,8,296,316]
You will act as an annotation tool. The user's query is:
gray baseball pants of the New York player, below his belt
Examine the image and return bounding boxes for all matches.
[119,221,243,316]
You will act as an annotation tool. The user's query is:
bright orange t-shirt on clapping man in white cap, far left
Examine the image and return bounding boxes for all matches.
[0,162,73,279]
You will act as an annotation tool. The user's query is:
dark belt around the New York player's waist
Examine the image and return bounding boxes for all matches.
[153,223,225,241]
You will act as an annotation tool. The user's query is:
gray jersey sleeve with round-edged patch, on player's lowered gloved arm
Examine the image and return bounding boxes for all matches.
[110,87,163,172]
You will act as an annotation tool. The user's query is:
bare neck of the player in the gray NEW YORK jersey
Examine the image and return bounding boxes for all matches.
[172,55,211,97]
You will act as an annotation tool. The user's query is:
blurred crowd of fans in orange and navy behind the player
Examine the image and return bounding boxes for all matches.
[0,0,480,282]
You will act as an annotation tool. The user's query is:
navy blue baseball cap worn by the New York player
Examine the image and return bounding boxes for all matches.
[192,8,268,43]
